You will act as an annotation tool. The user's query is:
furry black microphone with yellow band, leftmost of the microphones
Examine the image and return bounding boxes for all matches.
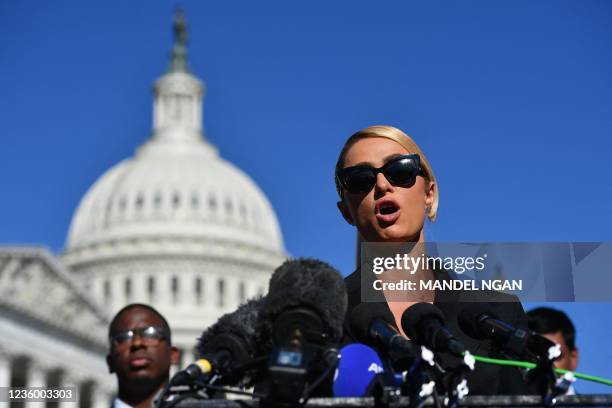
[170,297,263,386]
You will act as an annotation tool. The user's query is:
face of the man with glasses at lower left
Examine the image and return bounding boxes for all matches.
[106,307,179,383]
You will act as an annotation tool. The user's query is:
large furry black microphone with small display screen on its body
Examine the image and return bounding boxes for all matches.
[258,258,347,405]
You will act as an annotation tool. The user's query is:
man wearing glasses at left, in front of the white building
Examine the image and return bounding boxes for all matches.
[106,303,179,408]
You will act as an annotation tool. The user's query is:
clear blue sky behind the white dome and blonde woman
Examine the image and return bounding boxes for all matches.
[0,0,612,392]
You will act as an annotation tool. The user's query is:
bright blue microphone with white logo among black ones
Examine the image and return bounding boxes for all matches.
[334,343,383,397]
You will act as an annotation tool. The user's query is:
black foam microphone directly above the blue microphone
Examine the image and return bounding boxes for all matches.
[349,303,421,362]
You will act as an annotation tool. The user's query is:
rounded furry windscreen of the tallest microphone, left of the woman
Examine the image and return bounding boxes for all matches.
[259,258,348,342]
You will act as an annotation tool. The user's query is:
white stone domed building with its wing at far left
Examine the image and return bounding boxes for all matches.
[0,14,286,407]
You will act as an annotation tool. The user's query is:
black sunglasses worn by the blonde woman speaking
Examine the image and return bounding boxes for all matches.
[336,154,425,194]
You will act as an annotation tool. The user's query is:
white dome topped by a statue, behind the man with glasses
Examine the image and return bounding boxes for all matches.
[62,13,286,361]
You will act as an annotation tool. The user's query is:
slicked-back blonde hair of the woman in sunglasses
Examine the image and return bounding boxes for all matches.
[334,126,439,221]
